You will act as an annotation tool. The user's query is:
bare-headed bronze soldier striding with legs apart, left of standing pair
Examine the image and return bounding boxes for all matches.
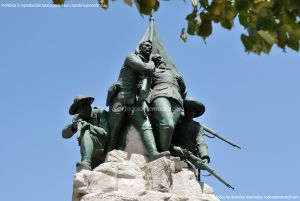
[107,41,170,160]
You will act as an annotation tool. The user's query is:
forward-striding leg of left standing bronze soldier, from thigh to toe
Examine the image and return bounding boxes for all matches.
[130,107,170,161]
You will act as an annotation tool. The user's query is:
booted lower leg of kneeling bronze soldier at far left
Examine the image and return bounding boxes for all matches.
[76,130,94,169]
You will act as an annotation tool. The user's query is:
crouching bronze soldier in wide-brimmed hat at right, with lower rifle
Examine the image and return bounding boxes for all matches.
[170,99,234,189]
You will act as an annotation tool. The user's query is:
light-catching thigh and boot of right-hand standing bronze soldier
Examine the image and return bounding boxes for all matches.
[153,97,175,151]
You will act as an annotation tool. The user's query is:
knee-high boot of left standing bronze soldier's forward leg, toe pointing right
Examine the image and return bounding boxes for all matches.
[141,130,170,161]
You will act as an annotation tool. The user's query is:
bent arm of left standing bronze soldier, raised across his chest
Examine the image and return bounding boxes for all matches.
[125,54,155,73]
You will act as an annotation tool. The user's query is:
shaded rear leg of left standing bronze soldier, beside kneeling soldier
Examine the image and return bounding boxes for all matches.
[106,102,126,153]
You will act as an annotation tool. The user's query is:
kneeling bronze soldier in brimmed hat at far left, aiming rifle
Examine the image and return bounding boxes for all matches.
[62,96,108,172]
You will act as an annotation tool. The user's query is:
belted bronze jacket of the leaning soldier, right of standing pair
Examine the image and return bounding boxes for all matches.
[150,68,186,106]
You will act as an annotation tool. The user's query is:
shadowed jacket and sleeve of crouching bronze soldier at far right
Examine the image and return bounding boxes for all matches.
[172,121,210,160]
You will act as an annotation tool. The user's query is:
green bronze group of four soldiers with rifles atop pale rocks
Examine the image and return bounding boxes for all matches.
[62,20,240,188]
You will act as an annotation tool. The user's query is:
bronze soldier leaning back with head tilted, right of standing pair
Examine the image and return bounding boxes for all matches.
[150,54,186,151]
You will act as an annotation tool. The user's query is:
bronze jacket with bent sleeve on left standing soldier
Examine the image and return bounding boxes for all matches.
[115,53,154,105]
